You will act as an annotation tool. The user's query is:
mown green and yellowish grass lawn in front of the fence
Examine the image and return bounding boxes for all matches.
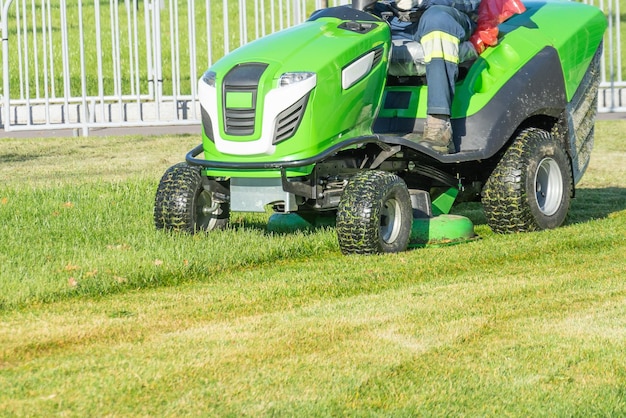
[0,121,626,417]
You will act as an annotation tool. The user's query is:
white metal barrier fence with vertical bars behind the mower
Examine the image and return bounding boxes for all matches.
[0,0,626,134]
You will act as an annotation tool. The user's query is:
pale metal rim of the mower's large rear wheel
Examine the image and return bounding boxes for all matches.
[535,158,563,216]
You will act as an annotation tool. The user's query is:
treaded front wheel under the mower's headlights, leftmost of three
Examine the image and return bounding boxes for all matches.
[154,163,229,233]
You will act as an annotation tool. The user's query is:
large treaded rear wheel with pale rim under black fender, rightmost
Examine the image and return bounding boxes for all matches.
[482,128,573,234]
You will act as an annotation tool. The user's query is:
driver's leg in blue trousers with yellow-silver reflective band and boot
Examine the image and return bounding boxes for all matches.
[414,6,473,152]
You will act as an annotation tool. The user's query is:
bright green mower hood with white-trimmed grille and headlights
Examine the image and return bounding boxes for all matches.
[199,7,390,168]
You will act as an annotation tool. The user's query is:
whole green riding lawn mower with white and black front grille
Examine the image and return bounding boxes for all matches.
[154,0,606,254]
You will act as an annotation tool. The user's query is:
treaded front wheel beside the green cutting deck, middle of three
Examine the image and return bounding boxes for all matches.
[336,171,413,254]
